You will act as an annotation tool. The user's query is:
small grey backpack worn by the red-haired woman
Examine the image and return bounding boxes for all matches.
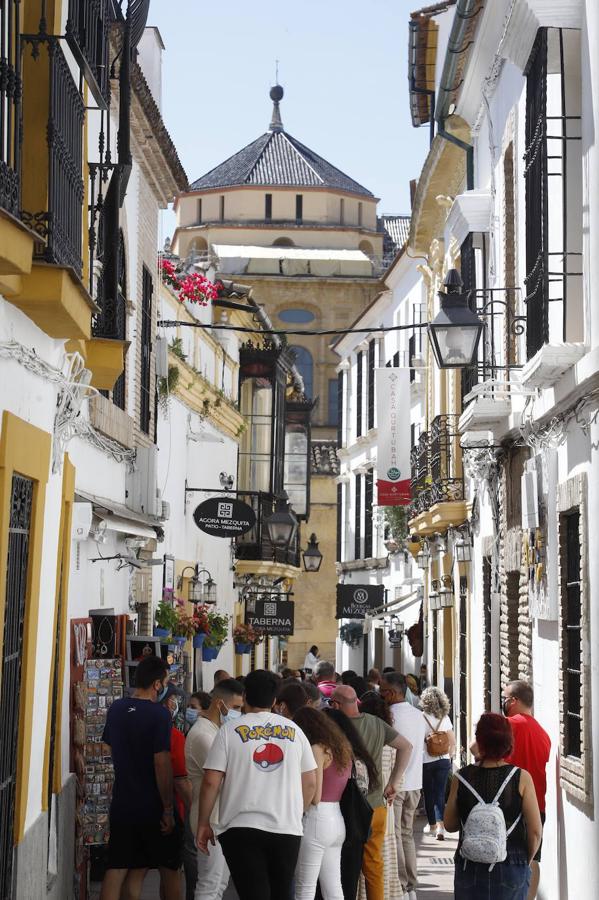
[456,766,522,872]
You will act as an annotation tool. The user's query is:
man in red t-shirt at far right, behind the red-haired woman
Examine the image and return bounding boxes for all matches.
[502,681,551,900]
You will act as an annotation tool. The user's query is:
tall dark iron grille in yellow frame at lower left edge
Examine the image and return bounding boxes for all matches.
[0,475,34,898]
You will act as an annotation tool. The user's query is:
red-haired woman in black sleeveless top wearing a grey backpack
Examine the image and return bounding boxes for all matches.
[445,713,543,900]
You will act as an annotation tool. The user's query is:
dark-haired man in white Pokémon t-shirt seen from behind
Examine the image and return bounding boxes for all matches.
[196,670,316,900]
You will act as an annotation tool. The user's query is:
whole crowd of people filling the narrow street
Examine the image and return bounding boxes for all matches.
[101,647,550,900]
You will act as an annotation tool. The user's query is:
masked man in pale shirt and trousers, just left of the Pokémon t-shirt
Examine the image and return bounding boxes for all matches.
[185,678,243,900]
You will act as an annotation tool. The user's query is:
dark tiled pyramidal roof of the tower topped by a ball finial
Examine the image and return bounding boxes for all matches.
[190,131,373,197]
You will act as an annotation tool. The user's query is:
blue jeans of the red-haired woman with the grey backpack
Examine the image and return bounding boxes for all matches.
[454,857,530,900]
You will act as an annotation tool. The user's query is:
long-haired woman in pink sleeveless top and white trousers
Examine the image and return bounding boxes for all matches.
[294,706,352,900]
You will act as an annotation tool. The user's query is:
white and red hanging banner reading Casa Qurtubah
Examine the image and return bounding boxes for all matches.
[375,367,411,506]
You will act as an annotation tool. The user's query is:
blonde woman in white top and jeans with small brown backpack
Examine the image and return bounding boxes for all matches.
[420,687,455,841]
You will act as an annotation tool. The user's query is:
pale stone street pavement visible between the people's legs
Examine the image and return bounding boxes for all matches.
[91,818,457,900]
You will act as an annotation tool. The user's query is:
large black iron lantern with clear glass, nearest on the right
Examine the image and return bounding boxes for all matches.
[428,269,484,369]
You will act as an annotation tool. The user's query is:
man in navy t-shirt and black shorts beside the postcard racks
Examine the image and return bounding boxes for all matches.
[100,656,180,900]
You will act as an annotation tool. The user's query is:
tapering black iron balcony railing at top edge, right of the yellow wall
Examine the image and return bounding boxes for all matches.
[66,0,110,108]
